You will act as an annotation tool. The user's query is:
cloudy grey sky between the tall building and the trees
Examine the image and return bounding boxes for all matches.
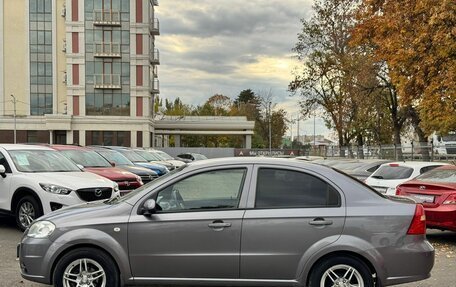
[156,0,327,140]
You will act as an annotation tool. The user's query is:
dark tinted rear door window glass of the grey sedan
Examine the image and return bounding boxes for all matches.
[255,168,340,208]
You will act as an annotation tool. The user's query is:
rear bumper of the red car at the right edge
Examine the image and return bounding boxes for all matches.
[424,205,456,231]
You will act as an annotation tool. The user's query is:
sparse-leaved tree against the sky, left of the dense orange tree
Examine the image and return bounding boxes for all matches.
[290,0,372,154]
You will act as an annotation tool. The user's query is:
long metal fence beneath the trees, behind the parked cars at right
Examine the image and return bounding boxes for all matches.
[301,142,456,161]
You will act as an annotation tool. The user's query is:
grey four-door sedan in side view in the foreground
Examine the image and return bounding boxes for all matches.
[18,158,434,287]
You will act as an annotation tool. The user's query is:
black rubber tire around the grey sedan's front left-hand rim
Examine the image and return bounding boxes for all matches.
[53,247,120,287]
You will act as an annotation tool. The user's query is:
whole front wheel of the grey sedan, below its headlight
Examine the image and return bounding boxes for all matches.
[54,248,120,287]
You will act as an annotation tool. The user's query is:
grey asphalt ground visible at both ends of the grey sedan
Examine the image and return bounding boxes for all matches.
[0,216,456,287]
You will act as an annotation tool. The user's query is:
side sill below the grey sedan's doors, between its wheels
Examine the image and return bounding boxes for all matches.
[129,277,299,286]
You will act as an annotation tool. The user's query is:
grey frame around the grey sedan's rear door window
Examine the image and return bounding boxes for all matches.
[247,164,345,210]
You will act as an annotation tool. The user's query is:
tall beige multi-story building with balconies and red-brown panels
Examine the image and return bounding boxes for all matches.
[0,0,160,147]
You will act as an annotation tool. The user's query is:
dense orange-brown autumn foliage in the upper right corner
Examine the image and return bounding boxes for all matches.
[355,0,456,135]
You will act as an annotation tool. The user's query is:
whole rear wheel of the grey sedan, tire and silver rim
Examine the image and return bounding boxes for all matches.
[309,256,375,287]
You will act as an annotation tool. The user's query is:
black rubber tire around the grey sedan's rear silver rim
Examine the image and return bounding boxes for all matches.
[309,256,375,287]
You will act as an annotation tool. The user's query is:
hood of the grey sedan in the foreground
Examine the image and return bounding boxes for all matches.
[39,200,133,228]
